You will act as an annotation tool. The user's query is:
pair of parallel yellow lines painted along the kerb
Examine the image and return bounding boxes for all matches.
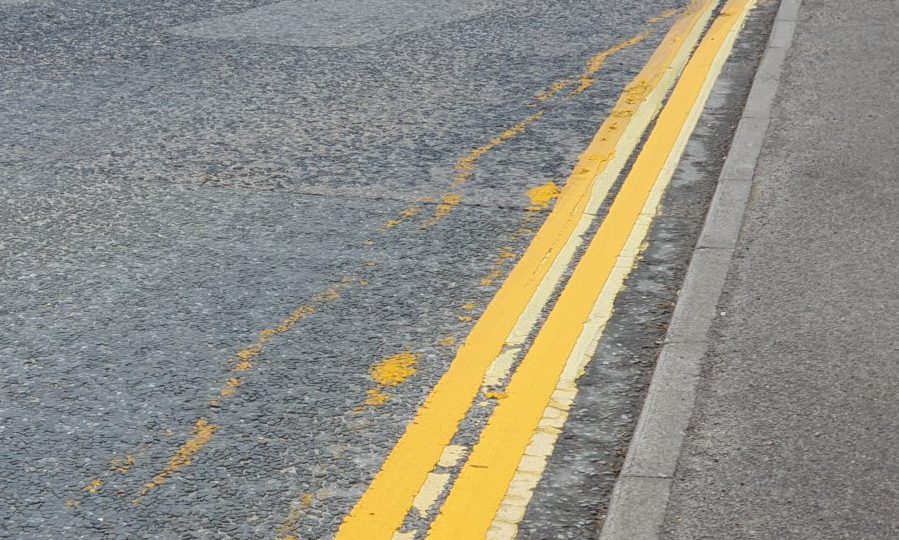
[337,0,754,540]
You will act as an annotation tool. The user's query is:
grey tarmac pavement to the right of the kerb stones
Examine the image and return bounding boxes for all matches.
[662,0,899,539]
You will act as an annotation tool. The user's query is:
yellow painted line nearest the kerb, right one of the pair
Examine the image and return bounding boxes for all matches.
[427,0,754,540]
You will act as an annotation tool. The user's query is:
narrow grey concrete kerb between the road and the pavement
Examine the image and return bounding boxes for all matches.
[599,0,802,540]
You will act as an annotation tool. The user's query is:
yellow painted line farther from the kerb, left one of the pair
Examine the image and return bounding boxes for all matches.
[337,0,715,540]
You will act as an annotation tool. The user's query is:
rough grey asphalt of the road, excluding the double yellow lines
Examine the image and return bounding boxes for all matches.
[0,0,764,539]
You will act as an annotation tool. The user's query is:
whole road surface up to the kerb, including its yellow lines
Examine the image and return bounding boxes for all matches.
[0,0,772,540]
